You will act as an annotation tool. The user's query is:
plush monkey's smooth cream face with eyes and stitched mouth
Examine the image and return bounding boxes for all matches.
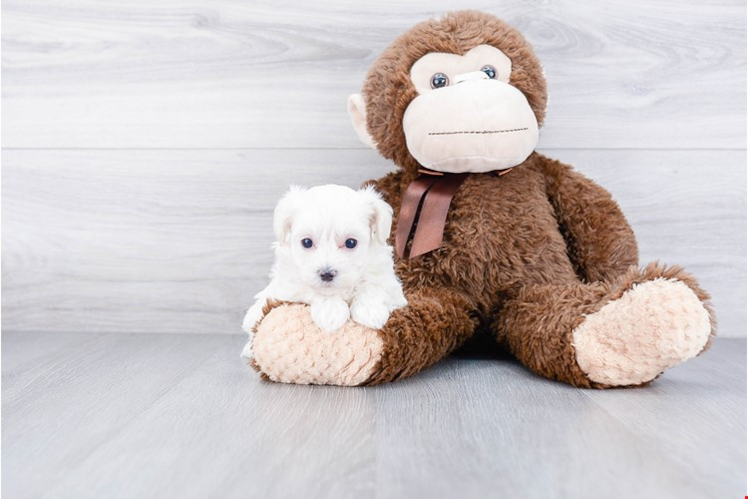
[403,45,538,173]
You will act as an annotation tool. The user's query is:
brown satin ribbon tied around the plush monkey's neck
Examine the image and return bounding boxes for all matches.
[395,169,511,259]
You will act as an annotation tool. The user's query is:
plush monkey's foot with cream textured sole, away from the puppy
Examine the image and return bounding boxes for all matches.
[572,266,713,386]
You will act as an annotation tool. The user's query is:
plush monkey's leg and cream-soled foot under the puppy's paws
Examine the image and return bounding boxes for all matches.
[250,287,478,385]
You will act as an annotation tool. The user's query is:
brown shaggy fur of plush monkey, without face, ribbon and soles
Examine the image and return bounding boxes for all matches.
[354,12,713,387]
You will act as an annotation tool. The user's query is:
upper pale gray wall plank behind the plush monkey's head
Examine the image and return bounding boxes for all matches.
[2,0,746,149]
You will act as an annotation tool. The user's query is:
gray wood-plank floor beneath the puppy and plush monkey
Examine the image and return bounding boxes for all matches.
[2,333,746,498]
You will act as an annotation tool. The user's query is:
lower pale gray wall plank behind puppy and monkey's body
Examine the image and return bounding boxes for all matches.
[2,150,746,337]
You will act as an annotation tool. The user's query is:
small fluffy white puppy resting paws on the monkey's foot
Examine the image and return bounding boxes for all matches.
[242,184,406,358]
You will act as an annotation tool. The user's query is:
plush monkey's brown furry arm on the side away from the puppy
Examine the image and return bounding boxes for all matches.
[538,155,639,283]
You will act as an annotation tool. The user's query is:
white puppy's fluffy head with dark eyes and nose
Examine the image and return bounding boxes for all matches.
[274,185,392,295]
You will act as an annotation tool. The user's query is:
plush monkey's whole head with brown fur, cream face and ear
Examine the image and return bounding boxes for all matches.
[348,11,546,173]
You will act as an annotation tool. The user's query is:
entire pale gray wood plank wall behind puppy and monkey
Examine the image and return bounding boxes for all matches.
[2,0,746,337]
